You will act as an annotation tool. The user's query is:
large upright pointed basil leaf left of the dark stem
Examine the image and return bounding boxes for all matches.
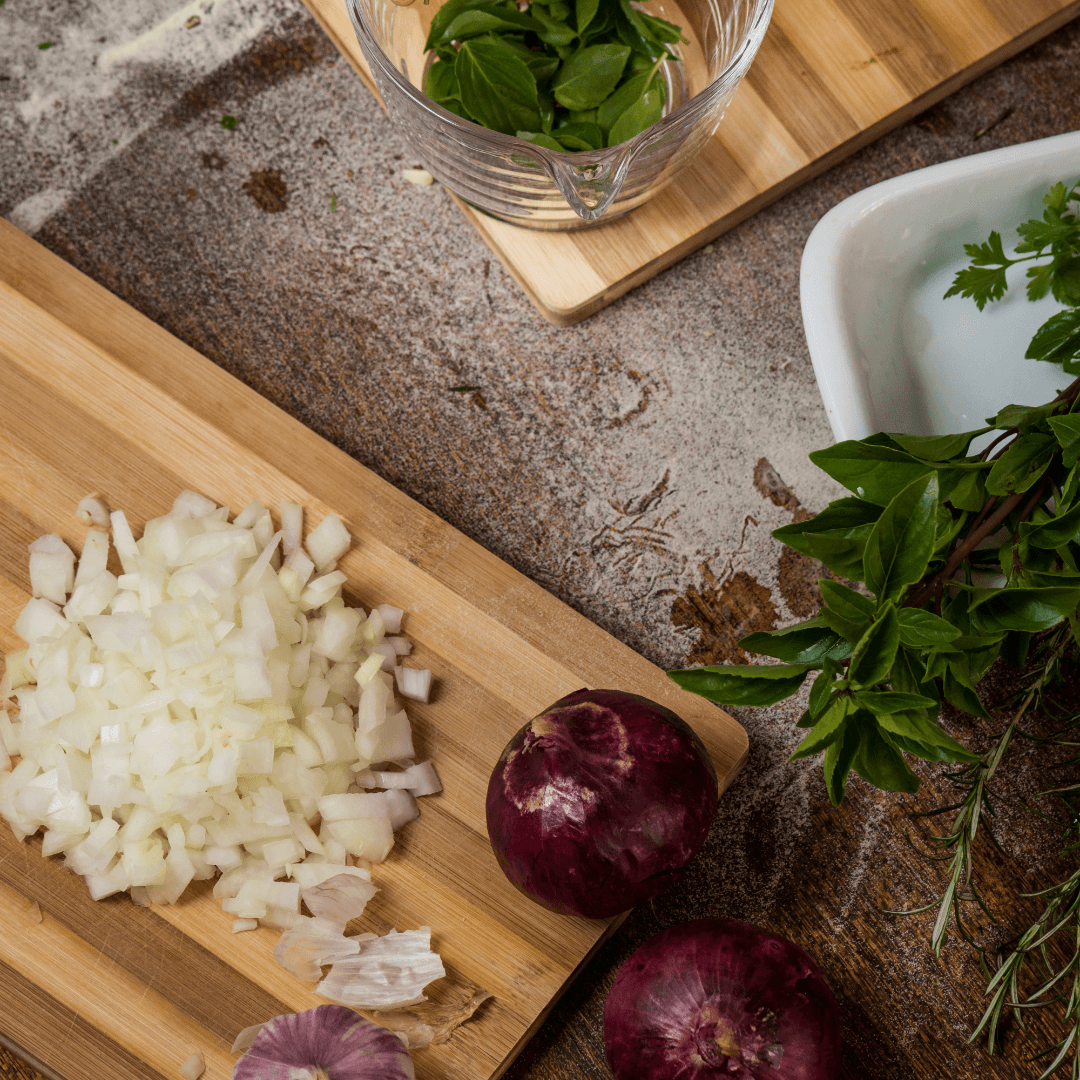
[863,473,937,604]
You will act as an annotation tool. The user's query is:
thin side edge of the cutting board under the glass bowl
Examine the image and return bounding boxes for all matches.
[303,0,1080,326]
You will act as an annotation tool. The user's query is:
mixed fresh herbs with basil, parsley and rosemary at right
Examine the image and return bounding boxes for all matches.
[669,183,1080,1080]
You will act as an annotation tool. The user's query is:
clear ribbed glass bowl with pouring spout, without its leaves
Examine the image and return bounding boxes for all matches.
[346,0,773,230]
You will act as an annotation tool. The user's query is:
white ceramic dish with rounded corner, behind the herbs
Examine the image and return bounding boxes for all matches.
[800,132,1080,441]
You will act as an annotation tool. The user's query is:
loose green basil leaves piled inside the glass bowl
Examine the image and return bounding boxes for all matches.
[423,0,686,151]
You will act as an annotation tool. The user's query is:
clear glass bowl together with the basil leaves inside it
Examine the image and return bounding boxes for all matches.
[347,0,772,229]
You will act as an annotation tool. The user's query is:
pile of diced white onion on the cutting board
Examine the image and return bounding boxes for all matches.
[0,491,440,937]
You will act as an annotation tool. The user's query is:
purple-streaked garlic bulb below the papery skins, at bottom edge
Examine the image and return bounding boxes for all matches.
[232,1005,416,1080]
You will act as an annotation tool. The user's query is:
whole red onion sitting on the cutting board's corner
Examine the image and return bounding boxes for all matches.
[487,690,717,919]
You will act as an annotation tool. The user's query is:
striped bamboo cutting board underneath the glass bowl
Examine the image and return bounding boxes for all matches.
[303,0,1080,326]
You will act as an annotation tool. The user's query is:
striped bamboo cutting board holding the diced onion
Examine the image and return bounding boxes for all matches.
[0,220,747,1080]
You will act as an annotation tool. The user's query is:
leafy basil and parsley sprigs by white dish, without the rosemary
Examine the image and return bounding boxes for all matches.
[669,177,1080,804]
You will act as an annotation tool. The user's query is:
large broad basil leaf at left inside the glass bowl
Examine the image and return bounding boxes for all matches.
[454,39,541,135]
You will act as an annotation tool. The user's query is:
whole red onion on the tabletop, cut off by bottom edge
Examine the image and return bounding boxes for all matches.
[604,919,840,1080]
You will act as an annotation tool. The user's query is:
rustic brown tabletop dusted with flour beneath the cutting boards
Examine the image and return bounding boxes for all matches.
[0,0,1080,1080]
